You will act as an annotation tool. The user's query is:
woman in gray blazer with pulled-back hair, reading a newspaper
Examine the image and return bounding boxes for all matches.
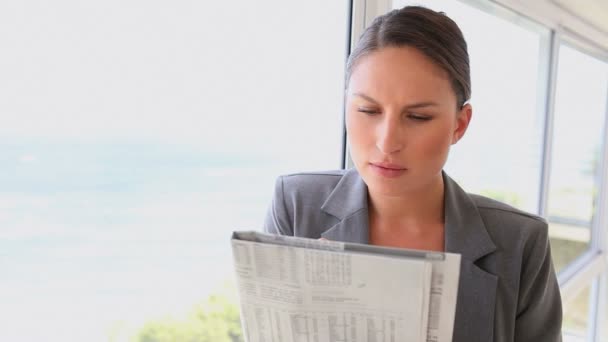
[265,7,562,342]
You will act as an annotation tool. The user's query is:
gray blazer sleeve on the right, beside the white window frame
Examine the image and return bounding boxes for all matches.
[515,222,562,342]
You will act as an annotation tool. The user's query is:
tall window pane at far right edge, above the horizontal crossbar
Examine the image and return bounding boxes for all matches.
[548,45,608,270]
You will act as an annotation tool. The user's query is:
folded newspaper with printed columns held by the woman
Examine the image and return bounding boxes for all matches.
[232,232,460,342]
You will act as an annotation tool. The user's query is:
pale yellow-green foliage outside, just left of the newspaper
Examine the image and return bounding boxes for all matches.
[135,284,243,342]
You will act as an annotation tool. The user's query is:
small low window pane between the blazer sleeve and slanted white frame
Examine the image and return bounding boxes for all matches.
[562,285,591,342]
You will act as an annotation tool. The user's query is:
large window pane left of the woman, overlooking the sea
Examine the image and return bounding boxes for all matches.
[0,0,348,341]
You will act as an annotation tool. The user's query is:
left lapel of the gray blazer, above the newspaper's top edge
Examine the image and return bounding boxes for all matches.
[321,169,369,243]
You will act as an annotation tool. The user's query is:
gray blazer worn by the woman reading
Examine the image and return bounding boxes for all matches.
[265,169,562,342]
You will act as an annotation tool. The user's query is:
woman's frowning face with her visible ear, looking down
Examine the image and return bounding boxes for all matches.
[346,47,471,196]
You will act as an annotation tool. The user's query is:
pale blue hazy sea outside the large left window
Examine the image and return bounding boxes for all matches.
[0,141,289,342]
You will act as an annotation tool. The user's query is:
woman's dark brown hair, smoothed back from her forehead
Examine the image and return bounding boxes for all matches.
[346,6,471,108]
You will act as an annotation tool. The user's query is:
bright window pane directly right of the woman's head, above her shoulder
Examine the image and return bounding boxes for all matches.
[393,0,548,213]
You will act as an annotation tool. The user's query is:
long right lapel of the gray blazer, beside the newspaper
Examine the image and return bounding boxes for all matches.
[443,173,498,342]
